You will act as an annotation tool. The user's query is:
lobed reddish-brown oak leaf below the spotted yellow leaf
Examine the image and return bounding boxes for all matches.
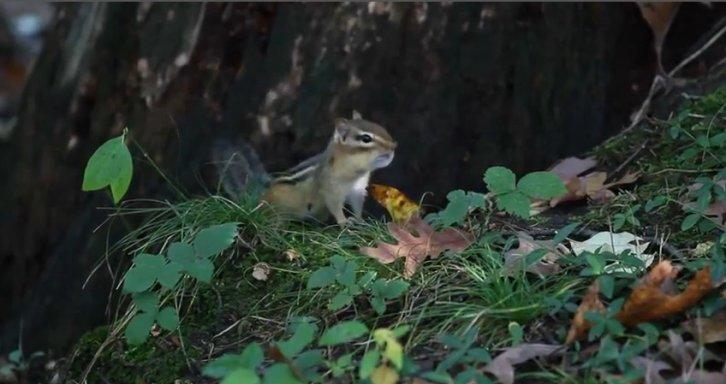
[360,217,474,278]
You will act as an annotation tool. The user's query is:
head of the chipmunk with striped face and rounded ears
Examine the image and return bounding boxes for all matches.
[333,112,398,170]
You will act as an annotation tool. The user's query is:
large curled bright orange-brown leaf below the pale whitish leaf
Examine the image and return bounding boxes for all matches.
[615,261,714,326]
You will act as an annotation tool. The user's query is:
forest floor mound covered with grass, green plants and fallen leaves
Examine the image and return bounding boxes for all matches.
[2,88,726,384]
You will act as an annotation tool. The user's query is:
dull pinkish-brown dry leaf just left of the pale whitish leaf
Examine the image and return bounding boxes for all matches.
[504,232,567,276]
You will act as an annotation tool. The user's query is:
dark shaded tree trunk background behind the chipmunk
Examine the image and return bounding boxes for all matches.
[0,3,725,352]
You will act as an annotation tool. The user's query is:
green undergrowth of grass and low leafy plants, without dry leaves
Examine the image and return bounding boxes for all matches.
[4,89,726,384]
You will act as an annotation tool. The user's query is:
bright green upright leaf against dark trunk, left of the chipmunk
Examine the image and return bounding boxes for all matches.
[81,134,133,203]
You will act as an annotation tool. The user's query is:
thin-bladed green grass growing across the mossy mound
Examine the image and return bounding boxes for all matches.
[58,89,726,383]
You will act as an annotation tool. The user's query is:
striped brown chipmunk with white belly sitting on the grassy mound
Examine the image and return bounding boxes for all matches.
[215,112,397,225]
